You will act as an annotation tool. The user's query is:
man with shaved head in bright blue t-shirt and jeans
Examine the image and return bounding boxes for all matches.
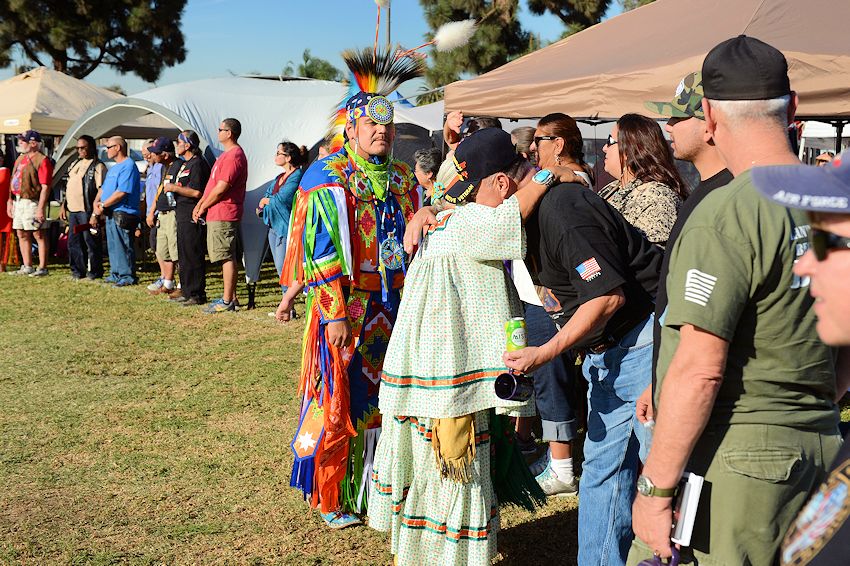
[95,136,141,287]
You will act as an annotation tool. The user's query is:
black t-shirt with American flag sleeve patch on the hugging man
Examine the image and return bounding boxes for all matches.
[529,183,663,347]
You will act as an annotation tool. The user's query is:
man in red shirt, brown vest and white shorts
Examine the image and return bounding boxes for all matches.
[6,130,53,277]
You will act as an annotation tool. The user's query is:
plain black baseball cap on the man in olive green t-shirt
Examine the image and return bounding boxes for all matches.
[702,35,791,100]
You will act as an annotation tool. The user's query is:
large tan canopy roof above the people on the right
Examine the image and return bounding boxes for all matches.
[445,0,850,119]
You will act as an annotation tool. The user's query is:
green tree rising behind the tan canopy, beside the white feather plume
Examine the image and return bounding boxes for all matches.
[417,0,530,104]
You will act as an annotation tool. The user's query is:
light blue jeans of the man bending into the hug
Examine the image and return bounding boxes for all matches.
[578,315,653,566]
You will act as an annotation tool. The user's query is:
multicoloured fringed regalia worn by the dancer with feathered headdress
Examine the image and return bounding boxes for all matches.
[281,141,420,513]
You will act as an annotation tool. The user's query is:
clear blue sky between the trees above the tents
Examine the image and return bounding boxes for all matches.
[0,0,619,95]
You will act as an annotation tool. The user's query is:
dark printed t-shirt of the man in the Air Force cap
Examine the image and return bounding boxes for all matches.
[779,434,850,566]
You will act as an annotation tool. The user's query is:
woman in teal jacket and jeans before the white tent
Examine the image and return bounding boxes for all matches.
[257,141,305,310]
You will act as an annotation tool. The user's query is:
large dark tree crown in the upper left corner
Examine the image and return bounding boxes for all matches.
[0,0,186,82]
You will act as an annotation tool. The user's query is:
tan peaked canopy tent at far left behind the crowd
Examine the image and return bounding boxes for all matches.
[0,67,173,138]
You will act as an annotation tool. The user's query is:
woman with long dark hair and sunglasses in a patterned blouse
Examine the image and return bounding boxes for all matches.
[599,114,688,248]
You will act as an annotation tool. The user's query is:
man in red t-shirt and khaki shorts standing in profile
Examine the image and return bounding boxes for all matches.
[192,118,248,314]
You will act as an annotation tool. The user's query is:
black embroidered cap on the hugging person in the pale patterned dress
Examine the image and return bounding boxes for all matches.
[443,128,521,204]
